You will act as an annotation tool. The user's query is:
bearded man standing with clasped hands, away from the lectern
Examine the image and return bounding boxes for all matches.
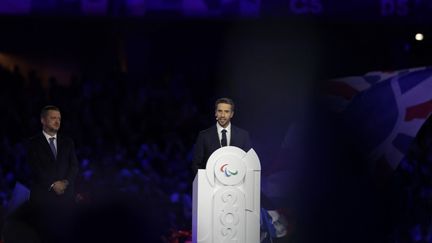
[28,106,78,204]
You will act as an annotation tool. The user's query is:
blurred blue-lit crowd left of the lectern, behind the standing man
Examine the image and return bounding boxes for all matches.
[0,66,207,241]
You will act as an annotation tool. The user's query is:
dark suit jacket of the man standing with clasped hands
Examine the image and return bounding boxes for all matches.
[27,132,78,204]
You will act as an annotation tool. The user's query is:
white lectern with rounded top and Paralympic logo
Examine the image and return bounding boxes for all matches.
[192,146,261,243]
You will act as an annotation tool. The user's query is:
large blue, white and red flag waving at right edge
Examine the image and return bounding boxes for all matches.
[326,67,432,169]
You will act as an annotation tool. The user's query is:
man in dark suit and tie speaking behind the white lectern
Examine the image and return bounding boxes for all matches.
[192,98,252,173]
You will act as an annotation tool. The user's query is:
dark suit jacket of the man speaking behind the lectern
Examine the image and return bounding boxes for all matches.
[192,124,252,173]
